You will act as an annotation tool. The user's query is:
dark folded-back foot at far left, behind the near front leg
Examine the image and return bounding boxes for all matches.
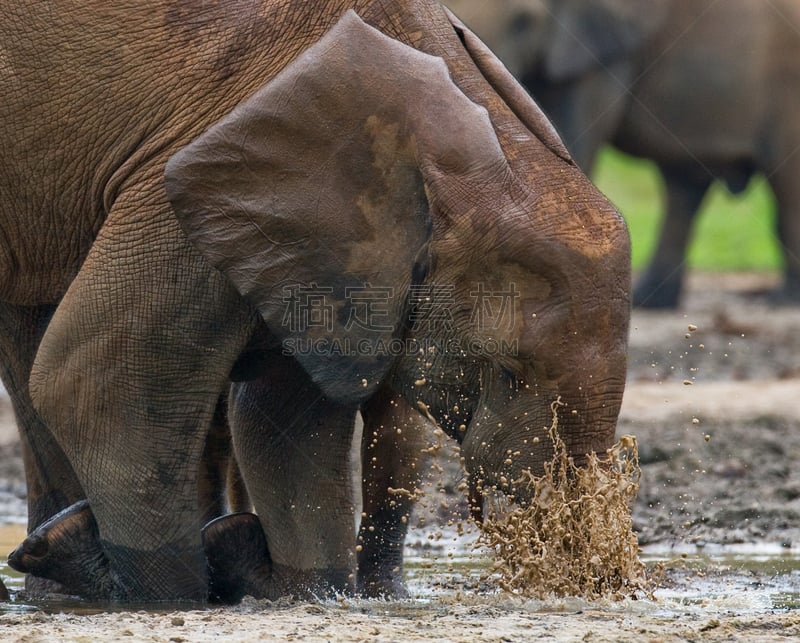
[8,500,113,599]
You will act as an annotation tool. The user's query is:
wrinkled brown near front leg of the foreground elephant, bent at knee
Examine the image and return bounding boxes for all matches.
[25,191,255,601]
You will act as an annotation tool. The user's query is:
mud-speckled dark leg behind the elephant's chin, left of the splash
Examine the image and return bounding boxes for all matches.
[358,389,429,597]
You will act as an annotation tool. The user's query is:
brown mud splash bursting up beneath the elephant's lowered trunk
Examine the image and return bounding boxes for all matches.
[478,400,657,599]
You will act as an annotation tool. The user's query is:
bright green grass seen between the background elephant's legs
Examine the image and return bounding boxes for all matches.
[592,148,782,271]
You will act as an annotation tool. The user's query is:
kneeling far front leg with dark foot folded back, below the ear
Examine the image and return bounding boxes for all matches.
[205,355,356,602]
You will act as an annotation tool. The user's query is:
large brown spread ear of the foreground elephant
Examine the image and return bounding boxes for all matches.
[165,11,505,402]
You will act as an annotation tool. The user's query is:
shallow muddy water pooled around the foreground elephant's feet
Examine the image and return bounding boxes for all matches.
[0,525,800,618]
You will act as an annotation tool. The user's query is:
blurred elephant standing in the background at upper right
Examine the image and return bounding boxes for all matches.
[446,0,800,307]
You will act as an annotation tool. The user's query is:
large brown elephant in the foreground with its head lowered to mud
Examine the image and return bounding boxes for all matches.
[0,0,630,600]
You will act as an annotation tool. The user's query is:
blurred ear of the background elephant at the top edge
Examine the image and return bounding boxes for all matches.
[543,0,667,82]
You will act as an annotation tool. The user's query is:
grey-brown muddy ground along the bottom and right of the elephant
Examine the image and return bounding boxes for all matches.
[0,275,800,641]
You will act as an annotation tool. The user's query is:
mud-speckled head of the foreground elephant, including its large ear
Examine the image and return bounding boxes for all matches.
[166,5,630,520]
